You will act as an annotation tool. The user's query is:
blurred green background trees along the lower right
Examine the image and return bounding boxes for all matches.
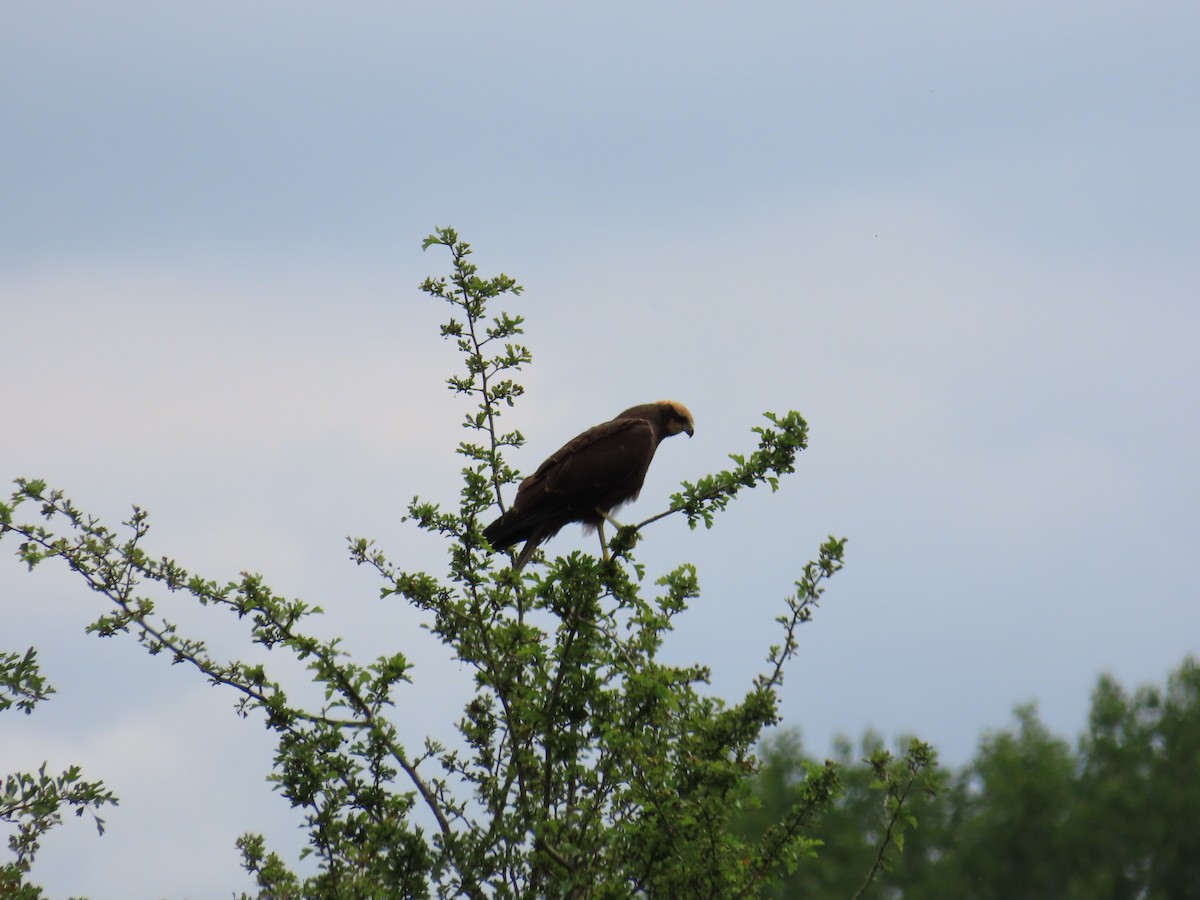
[736,659,1200,900]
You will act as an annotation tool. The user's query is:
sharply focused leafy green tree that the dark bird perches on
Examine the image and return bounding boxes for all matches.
[0,228,912,898]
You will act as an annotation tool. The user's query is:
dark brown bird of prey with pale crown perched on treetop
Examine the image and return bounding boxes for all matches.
[484,400,694,571]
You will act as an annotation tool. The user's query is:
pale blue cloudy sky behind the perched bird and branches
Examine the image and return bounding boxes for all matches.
[0,1,1200,900]
